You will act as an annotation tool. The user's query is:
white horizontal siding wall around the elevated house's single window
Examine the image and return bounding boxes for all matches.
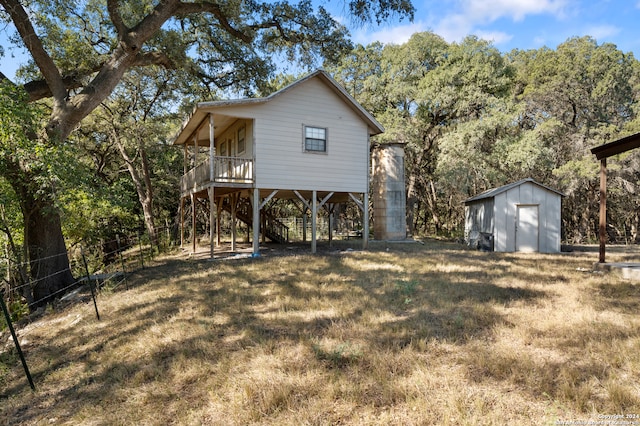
[209,79,369,193]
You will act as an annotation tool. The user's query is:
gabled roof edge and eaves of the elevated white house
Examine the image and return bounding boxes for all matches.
[173,70,384,145]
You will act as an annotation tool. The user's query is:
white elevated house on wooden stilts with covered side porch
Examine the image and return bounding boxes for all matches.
[173,70,384,257]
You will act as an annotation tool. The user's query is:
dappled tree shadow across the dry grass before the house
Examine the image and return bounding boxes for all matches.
[0,246,580,423]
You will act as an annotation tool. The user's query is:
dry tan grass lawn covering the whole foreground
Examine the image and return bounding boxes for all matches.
[0,242,640,425]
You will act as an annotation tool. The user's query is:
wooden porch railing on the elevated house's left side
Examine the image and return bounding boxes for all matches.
[180,157,254,192]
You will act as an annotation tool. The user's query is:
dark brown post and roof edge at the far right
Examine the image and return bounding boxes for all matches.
[591,133,640,263]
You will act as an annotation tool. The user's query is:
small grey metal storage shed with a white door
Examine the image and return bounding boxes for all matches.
[464,178,564,253]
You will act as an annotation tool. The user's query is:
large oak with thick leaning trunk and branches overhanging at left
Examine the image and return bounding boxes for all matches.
[0,0,413,302]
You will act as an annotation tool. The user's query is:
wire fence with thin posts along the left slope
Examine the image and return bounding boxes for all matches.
[0,227,176,389]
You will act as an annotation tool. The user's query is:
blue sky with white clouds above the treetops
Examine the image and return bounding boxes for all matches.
[0,0,640,77]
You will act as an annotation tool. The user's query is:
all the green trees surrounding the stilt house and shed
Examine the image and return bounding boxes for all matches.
[0,0,640,306]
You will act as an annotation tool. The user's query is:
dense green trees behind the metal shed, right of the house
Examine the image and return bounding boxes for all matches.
[330,32,640,243]
